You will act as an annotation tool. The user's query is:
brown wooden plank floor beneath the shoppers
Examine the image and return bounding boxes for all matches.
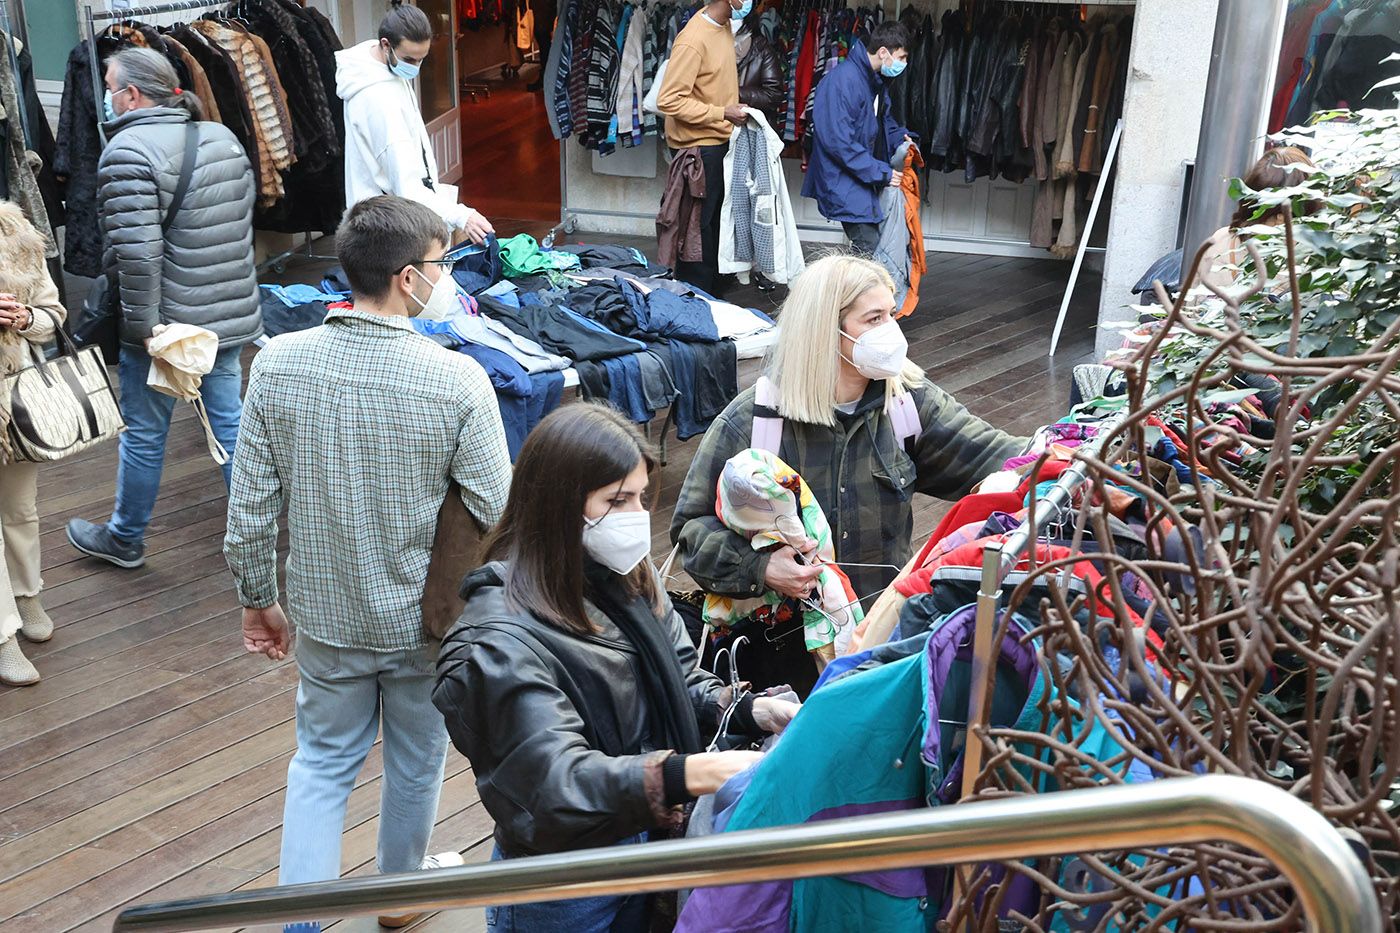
[0,243,1098,933]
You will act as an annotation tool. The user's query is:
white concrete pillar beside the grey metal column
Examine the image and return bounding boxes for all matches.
[1095,0,1220,357]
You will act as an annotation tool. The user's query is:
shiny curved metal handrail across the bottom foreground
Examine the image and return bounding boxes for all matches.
[112,775,1380,933]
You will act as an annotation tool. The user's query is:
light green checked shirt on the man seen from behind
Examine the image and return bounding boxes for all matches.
[224,308,511,651]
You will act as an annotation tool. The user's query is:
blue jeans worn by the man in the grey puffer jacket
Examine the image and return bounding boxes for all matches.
[108,346,244,541]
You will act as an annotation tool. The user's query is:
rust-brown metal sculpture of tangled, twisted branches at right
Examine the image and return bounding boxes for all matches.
[948,216,1400,933]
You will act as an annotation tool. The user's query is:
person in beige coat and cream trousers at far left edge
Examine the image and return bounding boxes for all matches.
[0,202,66,686]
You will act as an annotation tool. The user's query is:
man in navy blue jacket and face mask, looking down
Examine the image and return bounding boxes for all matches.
[802,20,909,254]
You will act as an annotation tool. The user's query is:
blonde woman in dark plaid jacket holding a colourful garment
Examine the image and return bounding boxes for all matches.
[671,255,1025,695]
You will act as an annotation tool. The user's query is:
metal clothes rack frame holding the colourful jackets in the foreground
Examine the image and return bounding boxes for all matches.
[959,413,1123,799]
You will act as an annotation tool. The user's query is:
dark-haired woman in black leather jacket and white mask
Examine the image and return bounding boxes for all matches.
[433,403,798,933]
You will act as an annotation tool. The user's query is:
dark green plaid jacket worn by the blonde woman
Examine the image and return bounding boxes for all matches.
[671,381,1026,609]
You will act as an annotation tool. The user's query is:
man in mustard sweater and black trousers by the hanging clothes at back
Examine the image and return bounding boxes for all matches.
[657,0,753,294]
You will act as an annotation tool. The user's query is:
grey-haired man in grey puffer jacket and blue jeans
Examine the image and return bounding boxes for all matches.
[69,49,262,567]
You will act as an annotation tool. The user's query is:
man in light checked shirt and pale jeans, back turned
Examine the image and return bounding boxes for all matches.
[224,196,511,925]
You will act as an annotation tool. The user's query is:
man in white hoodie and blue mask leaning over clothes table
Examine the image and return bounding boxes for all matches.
[336,0,496,242]
